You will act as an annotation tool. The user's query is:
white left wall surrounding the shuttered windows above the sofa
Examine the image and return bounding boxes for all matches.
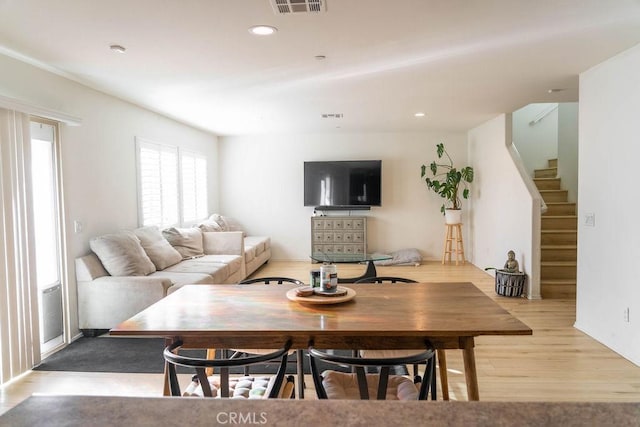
[0,51,218,333]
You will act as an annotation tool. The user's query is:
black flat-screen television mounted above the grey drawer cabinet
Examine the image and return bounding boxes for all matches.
[304,160,382,207]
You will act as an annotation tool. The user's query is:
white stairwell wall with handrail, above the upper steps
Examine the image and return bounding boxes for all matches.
[512,104,558,176]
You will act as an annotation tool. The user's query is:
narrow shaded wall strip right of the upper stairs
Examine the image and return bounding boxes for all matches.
[558,102,578,203]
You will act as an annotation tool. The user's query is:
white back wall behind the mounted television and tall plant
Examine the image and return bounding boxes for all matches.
[219,133,464,260]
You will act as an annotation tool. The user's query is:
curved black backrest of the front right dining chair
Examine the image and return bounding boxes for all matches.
[309,342,435,400]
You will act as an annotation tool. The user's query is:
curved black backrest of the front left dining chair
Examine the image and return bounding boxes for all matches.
[163,340,291,398]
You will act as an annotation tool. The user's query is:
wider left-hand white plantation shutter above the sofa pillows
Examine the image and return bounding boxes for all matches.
[136,139,179,228]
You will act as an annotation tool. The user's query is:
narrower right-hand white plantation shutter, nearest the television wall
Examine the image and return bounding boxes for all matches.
[180,151,208,223]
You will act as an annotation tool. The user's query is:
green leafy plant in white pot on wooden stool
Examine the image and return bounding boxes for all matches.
[420,143,473,224]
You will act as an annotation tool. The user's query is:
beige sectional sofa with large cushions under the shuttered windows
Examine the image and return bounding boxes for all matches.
[76,222,271,336]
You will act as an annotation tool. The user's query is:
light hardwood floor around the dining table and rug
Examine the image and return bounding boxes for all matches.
[0,261,640,413]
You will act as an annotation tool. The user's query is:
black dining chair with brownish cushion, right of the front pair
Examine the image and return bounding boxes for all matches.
[308,342,435,400]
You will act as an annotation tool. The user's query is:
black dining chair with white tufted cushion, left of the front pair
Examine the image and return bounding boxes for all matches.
[163,340,295,399]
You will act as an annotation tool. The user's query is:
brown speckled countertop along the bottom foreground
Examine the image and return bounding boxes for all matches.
[0,396,640,427]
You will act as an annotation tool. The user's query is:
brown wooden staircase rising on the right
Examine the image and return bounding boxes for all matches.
[533,159,578,298]
